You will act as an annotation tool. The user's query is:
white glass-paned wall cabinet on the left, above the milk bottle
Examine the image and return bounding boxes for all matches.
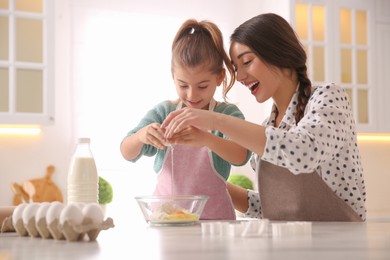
[0,0,54,125]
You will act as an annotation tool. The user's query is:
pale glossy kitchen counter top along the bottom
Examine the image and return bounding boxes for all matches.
[0,212,390,260]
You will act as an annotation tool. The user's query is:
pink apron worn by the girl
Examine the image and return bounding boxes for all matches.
[154,100,236,220]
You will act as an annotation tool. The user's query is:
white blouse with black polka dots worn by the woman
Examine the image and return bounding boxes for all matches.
[245,84,366,220]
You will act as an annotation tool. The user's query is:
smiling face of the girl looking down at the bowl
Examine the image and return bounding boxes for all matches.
[173,65,225,109]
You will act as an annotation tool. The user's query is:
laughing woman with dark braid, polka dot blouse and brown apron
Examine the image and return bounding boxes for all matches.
[162,13,366,221]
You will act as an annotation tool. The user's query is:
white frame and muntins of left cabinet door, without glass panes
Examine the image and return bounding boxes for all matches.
[0,0,55,125]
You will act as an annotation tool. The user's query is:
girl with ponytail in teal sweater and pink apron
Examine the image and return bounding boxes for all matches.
[121,19,251,220]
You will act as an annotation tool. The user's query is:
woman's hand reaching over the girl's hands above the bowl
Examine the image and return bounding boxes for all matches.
[161,108,217,139]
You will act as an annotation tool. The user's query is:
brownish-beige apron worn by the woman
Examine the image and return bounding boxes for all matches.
[257,160,362,222]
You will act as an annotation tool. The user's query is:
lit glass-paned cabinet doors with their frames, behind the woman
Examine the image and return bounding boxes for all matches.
[294,0,375,131]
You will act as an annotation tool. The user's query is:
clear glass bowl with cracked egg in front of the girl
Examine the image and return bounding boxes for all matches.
[135,195,209,225]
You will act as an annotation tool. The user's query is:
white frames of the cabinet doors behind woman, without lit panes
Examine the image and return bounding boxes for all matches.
[290,0,380,132]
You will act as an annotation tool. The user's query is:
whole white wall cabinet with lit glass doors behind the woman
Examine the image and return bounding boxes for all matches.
[262,0,390,133]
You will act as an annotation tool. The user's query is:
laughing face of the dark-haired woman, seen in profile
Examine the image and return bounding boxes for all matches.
[230,41,284,103]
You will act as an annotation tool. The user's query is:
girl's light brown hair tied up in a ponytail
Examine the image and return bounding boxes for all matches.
[171,19,235,100]
